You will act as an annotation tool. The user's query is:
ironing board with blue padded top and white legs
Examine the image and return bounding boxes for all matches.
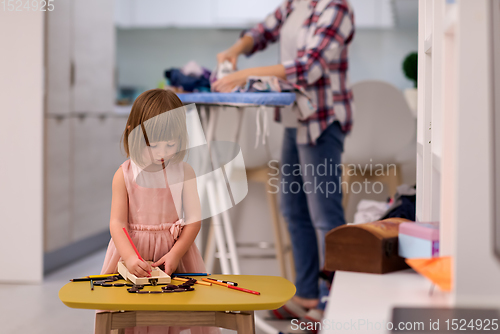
[177,92,295,334]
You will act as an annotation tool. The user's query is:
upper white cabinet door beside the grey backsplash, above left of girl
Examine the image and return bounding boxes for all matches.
[72,0,115,113]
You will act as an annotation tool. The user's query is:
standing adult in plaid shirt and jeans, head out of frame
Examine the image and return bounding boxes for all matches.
[212,0,354,321]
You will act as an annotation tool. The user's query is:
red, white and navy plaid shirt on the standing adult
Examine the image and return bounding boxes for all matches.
[242,0,354,144]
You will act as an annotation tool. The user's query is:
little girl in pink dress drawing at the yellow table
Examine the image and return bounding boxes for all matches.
[101,89,218,333]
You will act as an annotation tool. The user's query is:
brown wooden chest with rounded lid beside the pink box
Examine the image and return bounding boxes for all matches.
[325,218,409,274]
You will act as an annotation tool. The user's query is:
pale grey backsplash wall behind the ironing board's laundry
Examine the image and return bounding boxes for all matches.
[116,28,278,89]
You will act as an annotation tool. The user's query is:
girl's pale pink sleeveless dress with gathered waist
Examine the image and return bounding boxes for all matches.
[101,159,220,334]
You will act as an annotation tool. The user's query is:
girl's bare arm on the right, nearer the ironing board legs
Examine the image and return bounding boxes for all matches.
[153,163,201,275]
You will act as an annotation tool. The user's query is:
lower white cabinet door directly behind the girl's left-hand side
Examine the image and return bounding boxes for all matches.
[71,117,126,242]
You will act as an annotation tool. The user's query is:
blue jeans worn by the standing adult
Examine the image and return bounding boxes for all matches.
[280,122,345,309]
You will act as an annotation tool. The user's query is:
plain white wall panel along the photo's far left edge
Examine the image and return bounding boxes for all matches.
[0,10,44,283]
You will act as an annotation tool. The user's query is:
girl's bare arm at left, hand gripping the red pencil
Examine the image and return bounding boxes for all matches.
[109,167,151,277]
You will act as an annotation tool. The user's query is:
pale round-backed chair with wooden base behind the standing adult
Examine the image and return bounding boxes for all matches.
[342,80,416,211]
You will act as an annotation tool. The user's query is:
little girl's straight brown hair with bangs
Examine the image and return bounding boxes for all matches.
[122,89,188,167]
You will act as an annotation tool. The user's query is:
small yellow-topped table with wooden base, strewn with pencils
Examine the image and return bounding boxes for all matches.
[59,275,295,334]
